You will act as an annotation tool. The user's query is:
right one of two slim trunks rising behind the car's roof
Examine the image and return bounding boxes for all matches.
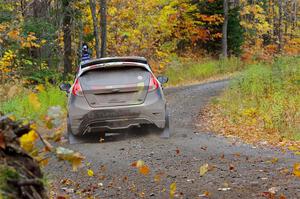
[100,0,107,57]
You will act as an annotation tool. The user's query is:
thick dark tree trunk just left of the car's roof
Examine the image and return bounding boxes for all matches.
[62,0,72,78]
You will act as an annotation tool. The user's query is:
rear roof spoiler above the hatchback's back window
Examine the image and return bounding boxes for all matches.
[81,57,148,69]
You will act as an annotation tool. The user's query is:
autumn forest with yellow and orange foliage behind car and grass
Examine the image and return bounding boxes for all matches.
[0,0,300,83]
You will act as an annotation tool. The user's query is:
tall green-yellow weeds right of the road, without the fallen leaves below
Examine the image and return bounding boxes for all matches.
[220,57,300,139]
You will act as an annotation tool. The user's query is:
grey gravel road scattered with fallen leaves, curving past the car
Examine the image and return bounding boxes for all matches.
[45,80,300,198]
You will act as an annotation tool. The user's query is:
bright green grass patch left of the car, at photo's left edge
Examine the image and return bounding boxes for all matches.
[0,84,67,120]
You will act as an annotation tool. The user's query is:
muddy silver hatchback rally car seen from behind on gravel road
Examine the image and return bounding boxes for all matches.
[60,57,169,135]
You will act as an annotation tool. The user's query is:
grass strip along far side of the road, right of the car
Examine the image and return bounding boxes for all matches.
[165,58,244,86]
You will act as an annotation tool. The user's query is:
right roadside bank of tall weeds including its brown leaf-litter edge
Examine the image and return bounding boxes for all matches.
[202,57,300,145]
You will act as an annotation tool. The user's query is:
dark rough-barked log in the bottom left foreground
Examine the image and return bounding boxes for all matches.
[0,114,48,199]
